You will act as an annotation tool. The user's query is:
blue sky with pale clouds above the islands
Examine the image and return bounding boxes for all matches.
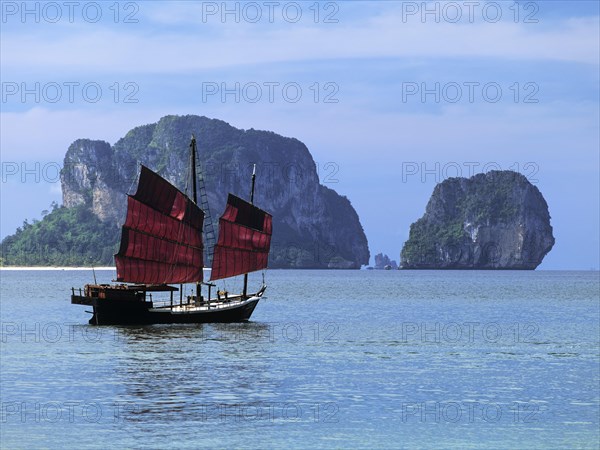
[0,1,600,270]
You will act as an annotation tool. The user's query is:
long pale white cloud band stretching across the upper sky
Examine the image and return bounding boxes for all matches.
[2,9,600,75]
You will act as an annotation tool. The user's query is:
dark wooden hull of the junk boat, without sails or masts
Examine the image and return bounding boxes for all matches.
[71,289,264,325]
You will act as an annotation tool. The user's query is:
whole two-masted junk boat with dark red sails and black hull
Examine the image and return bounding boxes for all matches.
[71,136,272,325]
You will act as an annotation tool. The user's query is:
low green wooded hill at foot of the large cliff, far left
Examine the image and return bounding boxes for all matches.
[1,206,120,266]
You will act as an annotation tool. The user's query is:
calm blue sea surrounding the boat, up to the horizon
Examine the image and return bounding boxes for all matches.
[0,270,600,449]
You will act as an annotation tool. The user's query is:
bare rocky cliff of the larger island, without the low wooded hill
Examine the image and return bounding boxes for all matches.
[61,116,369,268]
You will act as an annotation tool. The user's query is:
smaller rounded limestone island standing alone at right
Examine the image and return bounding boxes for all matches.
[400,171,554,269]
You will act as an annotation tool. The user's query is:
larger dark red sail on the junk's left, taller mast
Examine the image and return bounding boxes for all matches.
[115,166,204,284]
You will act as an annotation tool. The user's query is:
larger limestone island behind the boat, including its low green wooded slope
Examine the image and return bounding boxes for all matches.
[2,115,369,269]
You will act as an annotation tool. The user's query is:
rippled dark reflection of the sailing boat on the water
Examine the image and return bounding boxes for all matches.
[113,322,273,422]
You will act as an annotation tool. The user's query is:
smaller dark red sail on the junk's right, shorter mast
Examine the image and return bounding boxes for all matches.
[210,194,272,280]
